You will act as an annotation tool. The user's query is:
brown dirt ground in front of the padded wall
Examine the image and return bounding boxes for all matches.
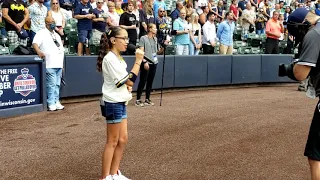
[0,84,317,180]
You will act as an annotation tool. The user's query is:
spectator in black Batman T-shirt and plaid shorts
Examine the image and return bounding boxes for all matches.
[2,0,29,47]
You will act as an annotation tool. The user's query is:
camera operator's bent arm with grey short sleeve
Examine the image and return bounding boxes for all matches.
[293,31,320,81]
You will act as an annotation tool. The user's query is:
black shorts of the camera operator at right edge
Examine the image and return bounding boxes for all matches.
[304,100,320,161]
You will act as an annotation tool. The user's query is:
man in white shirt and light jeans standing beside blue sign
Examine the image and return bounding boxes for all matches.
[32,16,64,111]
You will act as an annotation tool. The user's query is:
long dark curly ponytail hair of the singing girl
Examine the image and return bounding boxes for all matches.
[97,27,121,72]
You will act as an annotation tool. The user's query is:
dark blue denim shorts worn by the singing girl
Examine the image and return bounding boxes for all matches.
[104,102,127,124]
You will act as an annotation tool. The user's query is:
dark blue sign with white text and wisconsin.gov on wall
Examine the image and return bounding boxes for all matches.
[0,64,42,109]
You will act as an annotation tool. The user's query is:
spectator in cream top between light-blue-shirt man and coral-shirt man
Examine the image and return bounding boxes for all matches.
[241,2,256,34]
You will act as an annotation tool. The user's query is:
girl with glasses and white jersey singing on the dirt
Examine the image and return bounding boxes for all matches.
[97,27,144,180]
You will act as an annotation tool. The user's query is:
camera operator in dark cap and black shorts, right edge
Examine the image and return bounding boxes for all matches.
[279,8,320,180]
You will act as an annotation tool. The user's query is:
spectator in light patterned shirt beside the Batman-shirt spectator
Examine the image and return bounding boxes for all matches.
[28,0,47,42]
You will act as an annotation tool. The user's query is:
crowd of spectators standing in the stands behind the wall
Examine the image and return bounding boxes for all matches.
[0,0,320,56]
